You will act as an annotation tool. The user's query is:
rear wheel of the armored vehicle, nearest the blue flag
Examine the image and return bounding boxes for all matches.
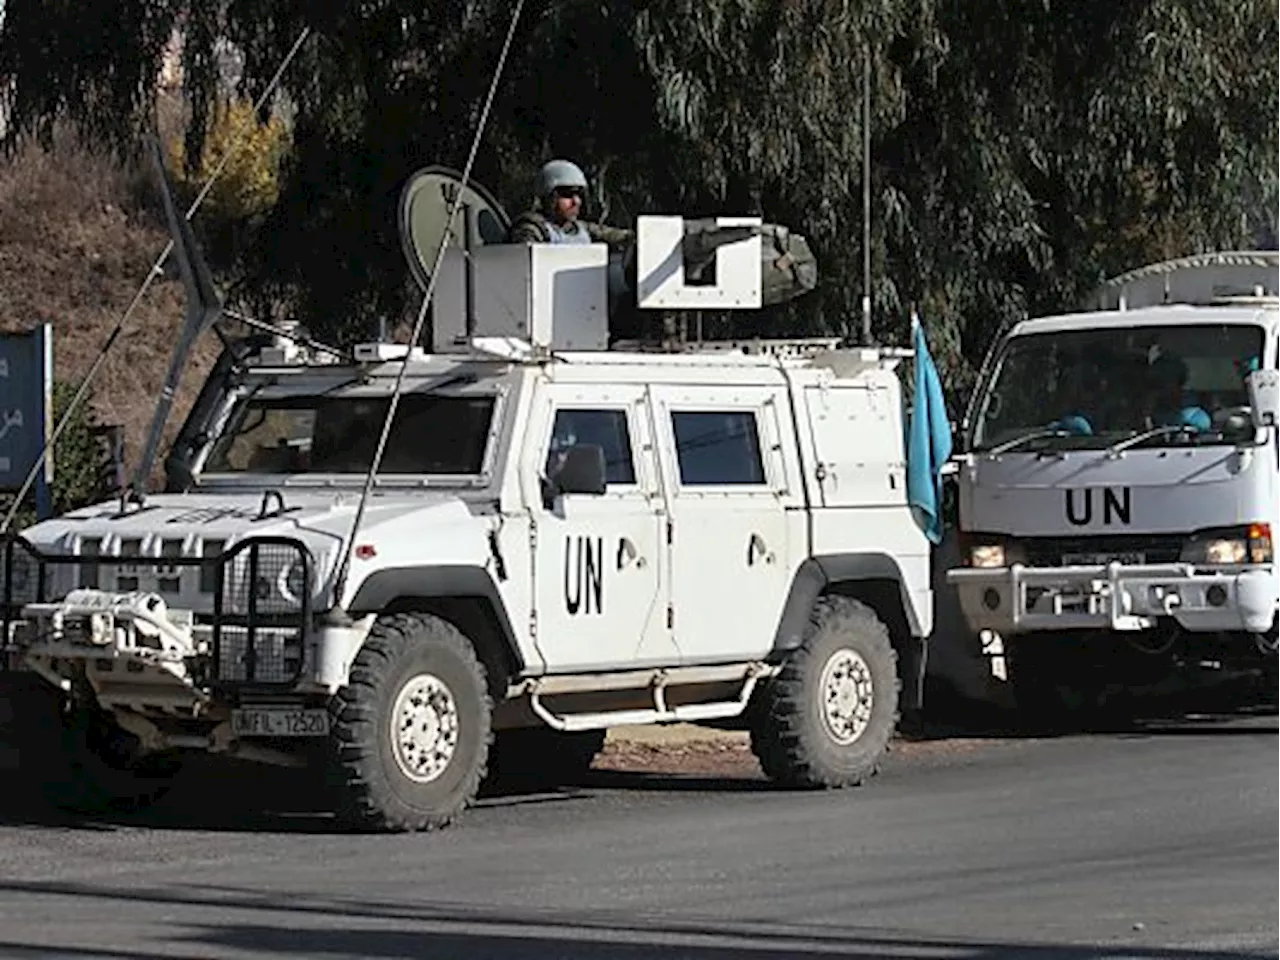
[751,596,901,790]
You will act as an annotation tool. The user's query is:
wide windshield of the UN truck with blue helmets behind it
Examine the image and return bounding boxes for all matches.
[973,324,1263,452]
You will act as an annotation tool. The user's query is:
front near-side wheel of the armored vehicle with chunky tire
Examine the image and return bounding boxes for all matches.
[329,613,493,832]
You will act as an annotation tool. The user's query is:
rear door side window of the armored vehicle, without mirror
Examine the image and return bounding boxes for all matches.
[671,411,765,486]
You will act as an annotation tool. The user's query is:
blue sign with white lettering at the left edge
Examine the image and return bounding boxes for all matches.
[0,324,54,516]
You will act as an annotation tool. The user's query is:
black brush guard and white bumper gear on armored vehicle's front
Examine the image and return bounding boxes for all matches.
[0,538,344,705]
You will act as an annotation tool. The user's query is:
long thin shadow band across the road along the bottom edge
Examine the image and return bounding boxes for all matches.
[0,882,1280,960]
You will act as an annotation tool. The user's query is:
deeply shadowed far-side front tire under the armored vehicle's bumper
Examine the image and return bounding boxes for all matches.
[4,676,182,814]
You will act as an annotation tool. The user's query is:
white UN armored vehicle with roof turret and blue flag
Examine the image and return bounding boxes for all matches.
[0,170,932,829]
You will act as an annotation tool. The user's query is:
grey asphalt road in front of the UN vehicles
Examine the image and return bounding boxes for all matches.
[0,717,1280,960]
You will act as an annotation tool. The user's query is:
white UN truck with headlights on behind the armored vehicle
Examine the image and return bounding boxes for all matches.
[947,252,1280,723]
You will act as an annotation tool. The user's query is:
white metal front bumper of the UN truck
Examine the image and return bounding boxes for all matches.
[947,563,1280,635]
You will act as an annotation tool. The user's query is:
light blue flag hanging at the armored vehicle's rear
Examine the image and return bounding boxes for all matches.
[906,314,951,543]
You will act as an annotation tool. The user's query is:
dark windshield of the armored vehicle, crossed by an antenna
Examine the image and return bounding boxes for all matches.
[205,394,494,476]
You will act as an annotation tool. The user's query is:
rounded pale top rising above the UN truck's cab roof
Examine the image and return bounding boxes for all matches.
[1088,250,1280,310]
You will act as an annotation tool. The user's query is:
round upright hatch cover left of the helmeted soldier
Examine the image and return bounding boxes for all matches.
[399,166,511,293]
